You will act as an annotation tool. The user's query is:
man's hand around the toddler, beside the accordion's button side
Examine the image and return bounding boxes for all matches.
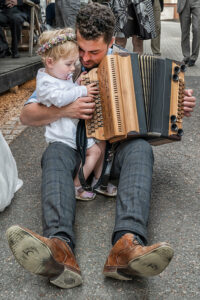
[60,97,95,120]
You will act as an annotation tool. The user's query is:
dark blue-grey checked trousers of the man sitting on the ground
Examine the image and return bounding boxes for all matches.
[42,139,154,244]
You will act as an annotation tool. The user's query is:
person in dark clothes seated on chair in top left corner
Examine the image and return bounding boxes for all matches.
[0,0,40,58]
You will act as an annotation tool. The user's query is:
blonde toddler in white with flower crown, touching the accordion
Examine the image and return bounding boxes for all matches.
[36,28,116,200]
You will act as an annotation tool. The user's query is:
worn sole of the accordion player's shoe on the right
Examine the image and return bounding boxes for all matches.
[103,245,174,280]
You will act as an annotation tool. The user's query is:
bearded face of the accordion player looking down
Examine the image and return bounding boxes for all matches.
[77,30,114,69]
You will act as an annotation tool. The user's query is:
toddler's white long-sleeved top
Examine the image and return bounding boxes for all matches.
[36,69,95,149]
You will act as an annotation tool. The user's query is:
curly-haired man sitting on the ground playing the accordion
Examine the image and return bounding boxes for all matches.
[7,3,195,288]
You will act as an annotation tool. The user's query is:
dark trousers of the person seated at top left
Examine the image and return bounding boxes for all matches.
[0,7,25,54]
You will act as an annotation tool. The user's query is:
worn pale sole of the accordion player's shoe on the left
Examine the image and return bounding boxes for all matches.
[6,225,82,288]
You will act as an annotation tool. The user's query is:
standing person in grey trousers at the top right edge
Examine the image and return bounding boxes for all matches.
[177,0,200,67]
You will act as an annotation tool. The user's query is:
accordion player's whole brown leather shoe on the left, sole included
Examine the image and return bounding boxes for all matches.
[6,225,82,288]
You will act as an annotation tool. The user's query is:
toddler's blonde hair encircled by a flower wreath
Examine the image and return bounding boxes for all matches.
[38,28,78,62]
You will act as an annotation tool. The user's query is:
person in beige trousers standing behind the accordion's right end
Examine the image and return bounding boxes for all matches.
[151,0,163,56]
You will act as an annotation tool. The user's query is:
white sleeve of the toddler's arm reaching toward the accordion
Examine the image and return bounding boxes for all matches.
[36,77,87,107]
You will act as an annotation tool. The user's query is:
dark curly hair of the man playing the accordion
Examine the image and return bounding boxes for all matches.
[76,3,115,44]
